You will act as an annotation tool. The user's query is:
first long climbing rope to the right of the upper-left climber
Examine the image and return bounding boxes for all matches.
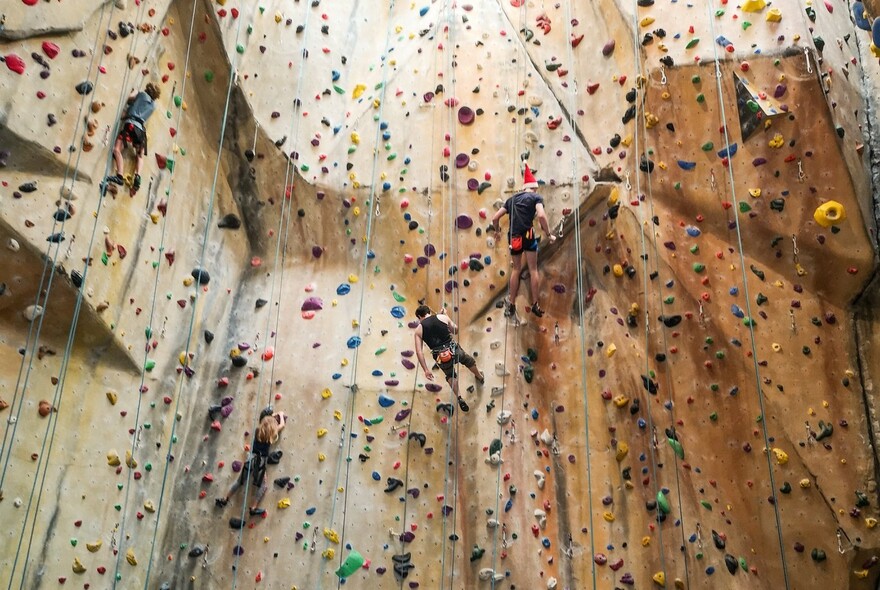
[114,0,196,579]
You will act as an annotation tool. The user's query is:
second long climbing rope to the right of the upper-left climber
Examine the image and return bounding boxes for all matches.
[138,8,244,589]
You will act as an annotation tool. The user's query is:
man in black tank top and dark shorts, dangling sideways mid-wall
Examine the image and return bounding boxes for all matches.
[415,305,485,412]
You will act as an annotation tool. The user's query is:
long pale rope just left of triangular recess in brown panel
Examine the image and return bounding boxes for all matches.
[706,0,791,590]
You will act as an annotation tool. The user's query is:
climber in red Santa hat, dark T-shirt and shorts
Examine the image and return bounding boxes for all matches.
[492,164,556,318]
